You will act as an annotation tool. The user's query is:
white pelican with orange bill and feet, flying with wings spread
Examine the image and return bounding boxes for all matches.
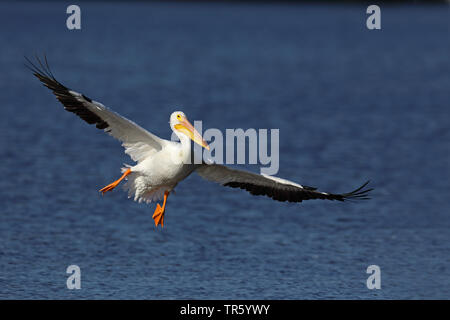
[26,58,372,227]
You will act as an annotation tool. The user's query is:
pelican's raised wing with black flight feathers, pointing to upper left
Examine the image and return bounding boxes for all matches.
[25,57,167,162]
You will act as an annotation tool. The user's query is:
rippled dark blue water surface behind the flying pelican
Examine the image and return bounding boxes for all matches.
[0,2,450,299]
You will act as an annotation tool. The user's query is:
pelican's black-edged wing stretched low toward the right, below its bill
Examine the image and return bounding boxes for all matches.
[196,164,372,202]
